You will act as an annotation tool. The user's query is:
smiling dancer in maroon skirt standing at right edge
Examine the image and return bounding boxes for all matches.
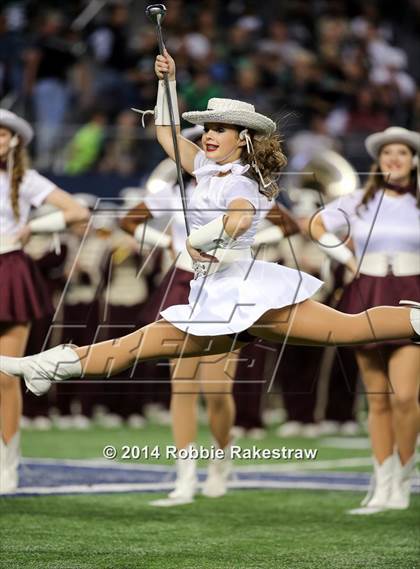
[309,127,420,514]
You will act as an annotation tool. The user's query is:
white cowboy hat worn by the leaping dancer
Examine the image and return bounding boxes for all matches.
[182,98,277,134]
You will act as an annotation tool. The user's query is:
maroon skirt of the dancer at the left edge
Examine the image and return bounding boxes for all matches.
[0,251,54,323]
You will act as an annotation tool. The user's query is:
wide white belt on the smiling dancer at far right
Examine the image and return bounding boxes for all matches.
[359,253,420,277]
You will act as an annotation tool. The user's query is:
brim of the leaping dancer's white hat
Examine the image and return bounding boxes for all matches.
[182,111,277,135]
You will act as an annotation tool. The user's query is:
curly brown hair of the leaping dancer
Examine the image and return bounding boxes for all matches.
[240,127,287,200]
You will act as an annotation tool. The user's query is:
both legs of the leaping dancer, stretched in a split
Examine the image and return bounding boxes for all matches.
[0,300,420,388]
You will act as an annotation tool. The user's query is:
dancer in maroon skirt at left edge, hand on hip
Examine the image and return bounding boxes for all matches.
[0,109,88,493]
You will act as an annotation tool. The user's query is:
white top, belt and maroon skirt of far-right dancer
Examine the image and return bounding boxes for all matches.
[321,190,420,347]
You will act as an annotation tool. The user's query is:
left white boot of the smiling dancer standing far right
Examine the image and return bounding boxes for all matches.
[349,454,395,515]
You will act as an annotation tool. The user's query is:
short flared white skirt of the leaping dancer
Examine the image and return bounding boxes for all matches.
[160,261,323,336]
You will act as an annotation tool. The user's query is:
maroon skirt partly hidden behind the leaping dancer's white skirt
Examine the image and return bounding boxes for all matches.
[139,267,194,323]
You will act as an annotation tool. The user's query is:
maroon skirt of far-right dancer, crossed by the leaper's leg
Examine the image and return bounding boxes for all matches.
[337,275,420,349]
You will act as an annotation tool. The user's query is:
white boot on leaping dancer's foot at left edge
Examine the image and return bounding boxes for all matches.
[0,344,82,395]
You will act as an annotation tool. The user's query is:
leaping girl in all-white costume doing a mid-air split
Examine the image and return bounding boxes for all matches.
[0,33,420,395]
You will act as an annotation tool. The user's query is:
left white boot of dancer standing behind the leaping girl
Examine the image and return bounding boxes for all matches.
[151,444,198,507]
